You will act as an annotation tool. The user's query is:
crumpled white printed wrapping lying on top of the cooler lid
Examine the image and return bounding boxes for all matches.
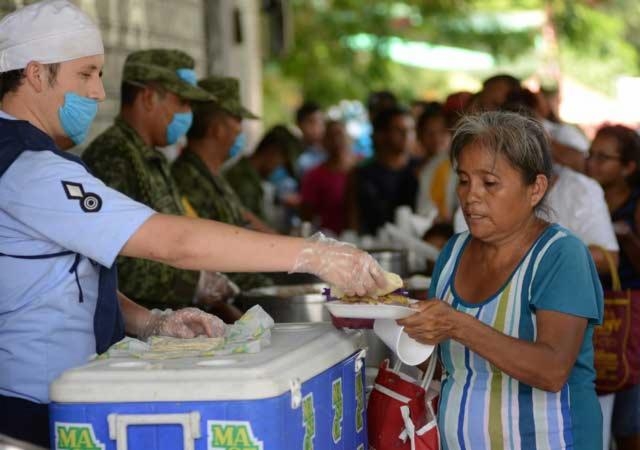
[96,305,274,360]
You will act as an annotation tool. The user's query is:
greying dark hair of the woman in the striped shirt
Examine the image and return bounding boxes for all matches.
[451,111,553,213]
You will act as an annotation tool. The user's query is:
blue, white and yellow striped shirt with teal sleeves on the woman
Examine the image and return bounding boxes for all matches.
[430,225,603,450]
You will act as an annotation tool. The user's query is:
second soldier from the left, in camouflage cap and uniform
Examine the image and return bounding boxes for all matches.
[171,76,273,290]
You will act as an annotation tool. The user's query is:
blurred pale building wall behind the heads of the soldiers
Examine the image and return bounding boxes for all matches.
[0,0,262,148]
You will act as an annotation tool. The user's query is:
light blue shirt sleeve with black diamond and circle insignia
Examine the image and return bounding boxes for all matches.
[0,151,155,267]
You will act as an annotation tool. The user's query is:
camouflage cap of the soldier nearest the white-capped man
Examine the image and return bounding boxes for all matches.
[122,48,216,102]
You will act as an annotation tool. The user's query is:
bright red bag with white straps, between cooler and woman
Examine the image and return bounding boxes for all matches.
[367,352,440,450]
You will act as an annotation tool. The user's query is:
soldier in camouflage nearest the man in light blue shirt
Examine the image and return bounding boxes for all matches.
[83,49,238,316]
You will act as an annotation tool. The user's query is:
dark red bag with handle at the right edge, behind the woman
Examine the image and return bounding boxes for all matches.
[593,249,640,394]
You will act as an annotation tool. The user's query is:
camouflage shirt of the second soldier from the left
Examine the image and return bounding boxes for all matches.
[171,149,272,290]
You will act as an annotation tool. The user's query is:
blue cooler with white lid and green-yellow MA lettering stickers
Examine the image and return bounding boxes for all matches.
[50,323,368,450]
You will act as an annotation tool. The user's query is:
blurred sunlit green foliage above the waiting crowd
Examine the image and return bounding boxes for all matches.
[264,0,640,124]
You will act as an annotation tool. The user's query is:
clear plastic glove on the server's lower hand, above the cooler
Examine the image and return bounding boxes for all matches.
[138,308,226,340]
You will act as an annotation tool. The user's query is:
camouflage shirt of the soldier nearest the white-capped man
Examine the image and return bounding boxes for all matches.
[82,117,200,308]
